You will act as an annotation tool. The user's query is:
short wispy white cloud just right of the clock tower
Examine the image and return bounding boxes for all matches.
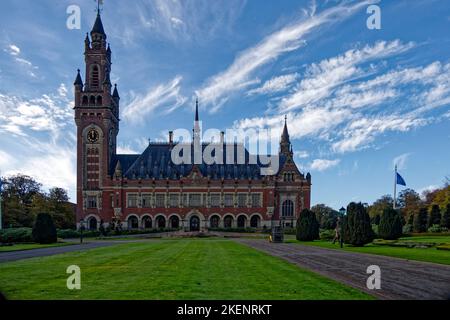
[123,75,187,123]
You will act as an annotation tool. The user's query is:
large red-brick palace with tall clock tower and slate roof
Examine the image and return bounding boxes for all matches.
[74,14,311,231]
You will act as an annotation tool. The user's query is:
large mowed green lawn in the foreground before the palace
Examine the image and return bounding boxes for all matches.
[0,240,372,300]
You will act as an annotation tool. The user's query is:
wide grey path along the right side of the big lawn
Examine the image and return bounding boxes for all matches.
[235,238,450,300]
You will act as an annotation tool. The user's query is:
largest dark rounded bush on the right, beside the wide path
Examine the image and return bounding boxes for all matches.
[344,202,375,246]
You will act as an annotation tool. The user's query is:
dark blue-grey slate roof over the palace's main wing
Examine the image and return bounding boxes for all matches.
[110,143,286,180]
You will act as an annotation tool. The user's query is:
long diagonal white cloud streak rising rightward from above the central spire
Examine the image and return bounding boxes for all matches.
[197,1,372,112]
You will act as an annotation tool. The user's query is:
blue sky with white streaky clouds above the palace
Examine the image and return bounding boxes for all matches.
[0,0,450,208]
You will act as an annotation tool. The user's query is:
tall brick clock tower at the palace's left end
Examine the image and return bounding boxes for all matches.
[74,11,120,222]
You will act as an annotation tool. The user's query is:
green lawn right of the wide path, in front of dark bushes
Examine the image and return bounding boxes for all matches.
[288,236,450,265]
